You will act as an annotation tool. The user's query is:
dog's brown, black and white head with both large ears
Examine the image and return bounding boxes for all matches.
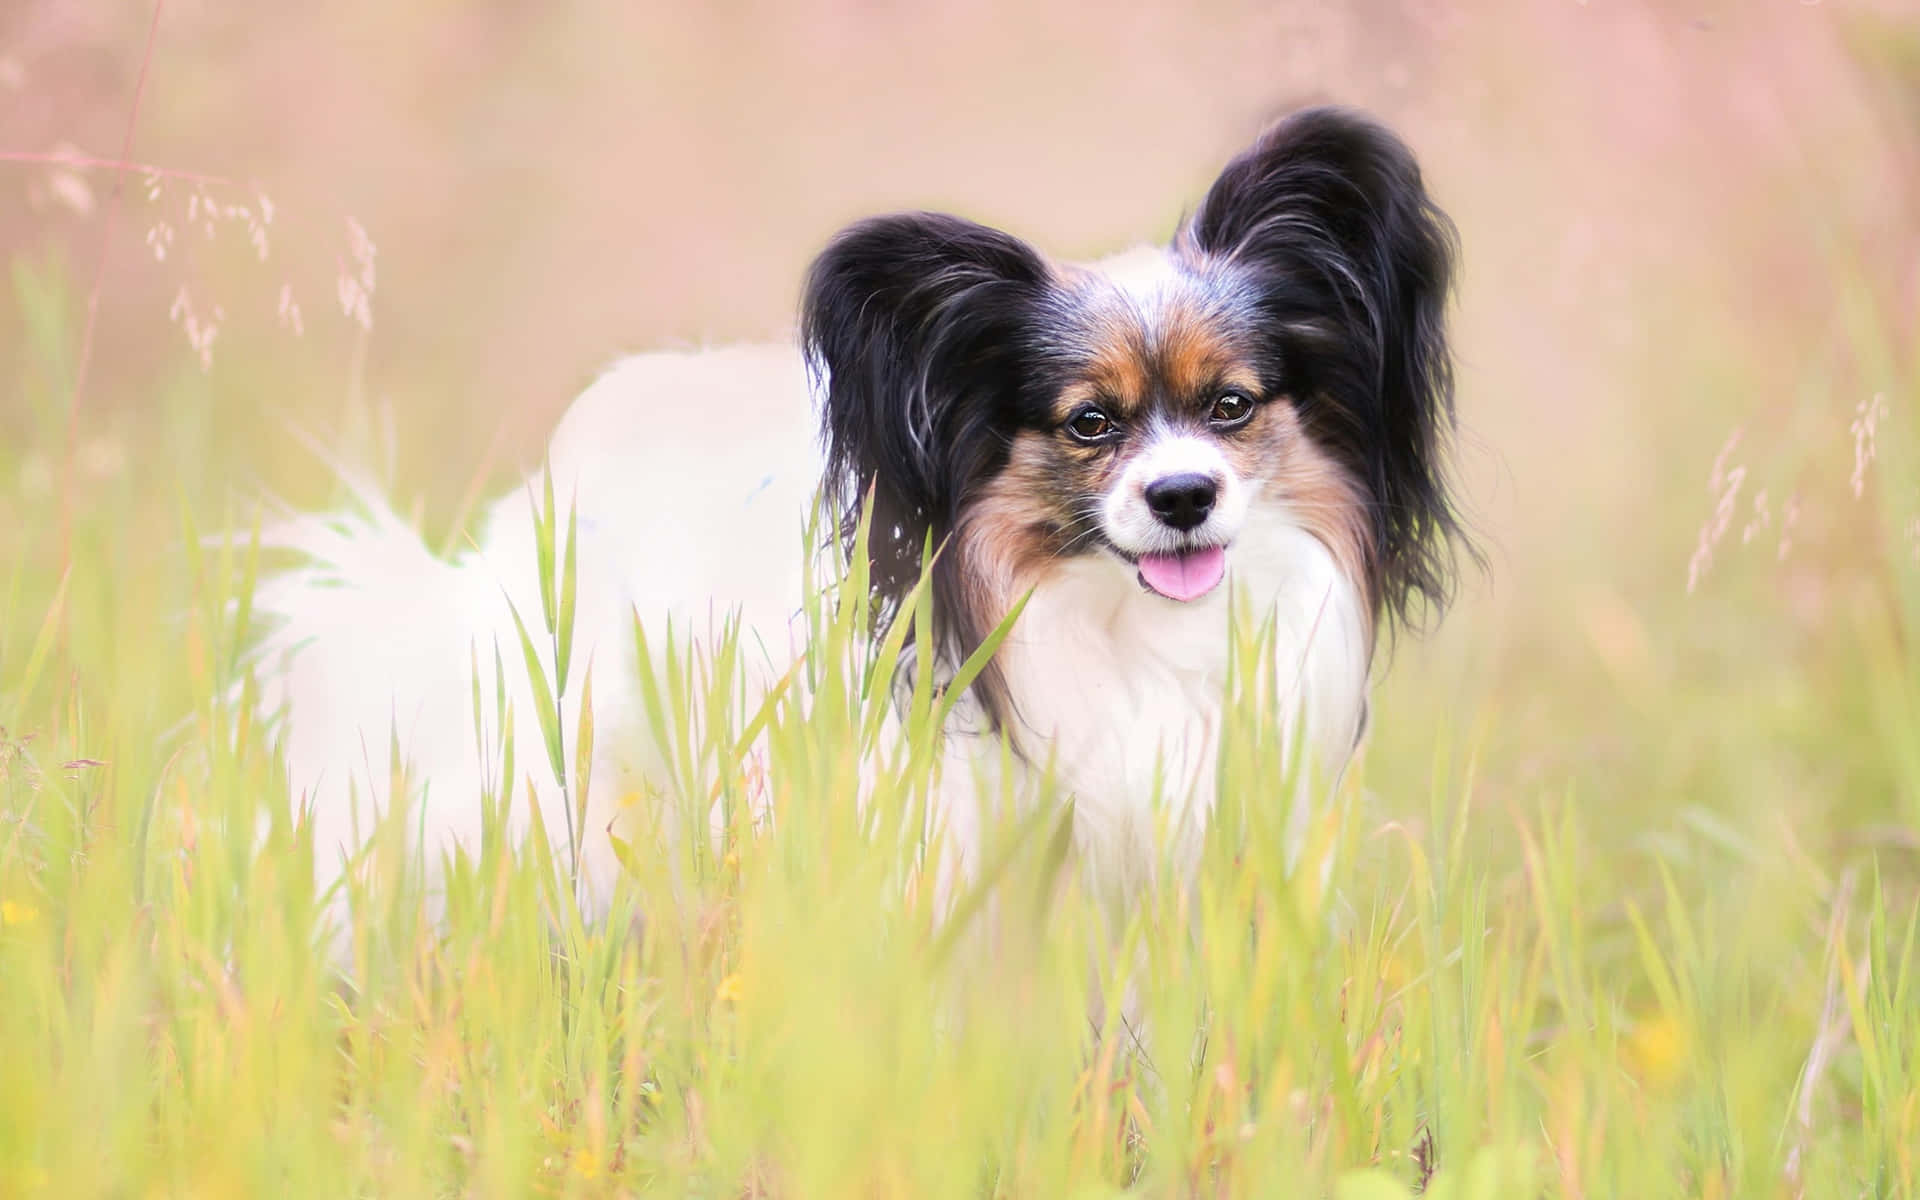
[803,108,1457,721]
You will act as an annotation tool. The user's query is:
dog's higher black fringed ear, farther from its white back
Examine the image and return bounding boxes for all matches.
[1181,108,1471,620]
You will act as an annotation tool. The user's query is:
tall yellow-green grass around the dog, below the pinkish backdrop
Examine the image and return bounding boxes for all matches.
[0,245,1920,1200]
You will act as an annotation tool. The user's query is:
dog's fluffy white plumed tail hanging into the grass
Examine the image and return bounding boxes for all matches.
[252,468,564,925]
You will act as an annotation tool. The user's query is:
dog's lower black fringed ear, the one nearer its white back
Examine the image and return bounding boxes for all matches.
[801,213,1050,616]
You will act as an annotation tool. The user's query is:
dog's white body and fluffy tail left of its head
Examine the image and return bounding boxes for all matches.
[255,346,820,933]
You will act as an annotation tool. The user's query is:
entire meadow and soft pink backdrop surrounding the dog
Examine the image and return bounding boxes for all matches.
[0,0,1920,1200]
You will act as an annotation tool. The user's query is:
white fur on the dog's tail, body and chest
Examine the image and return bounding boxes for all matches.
[255,348,1369,933]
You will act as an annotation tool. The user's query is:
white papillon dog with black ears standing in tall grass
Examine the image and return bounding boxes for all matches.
[255,108,1461,925]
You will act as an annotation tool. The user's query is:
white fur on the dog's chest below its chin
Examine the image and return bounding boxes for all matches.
[940,499,1369,883]
